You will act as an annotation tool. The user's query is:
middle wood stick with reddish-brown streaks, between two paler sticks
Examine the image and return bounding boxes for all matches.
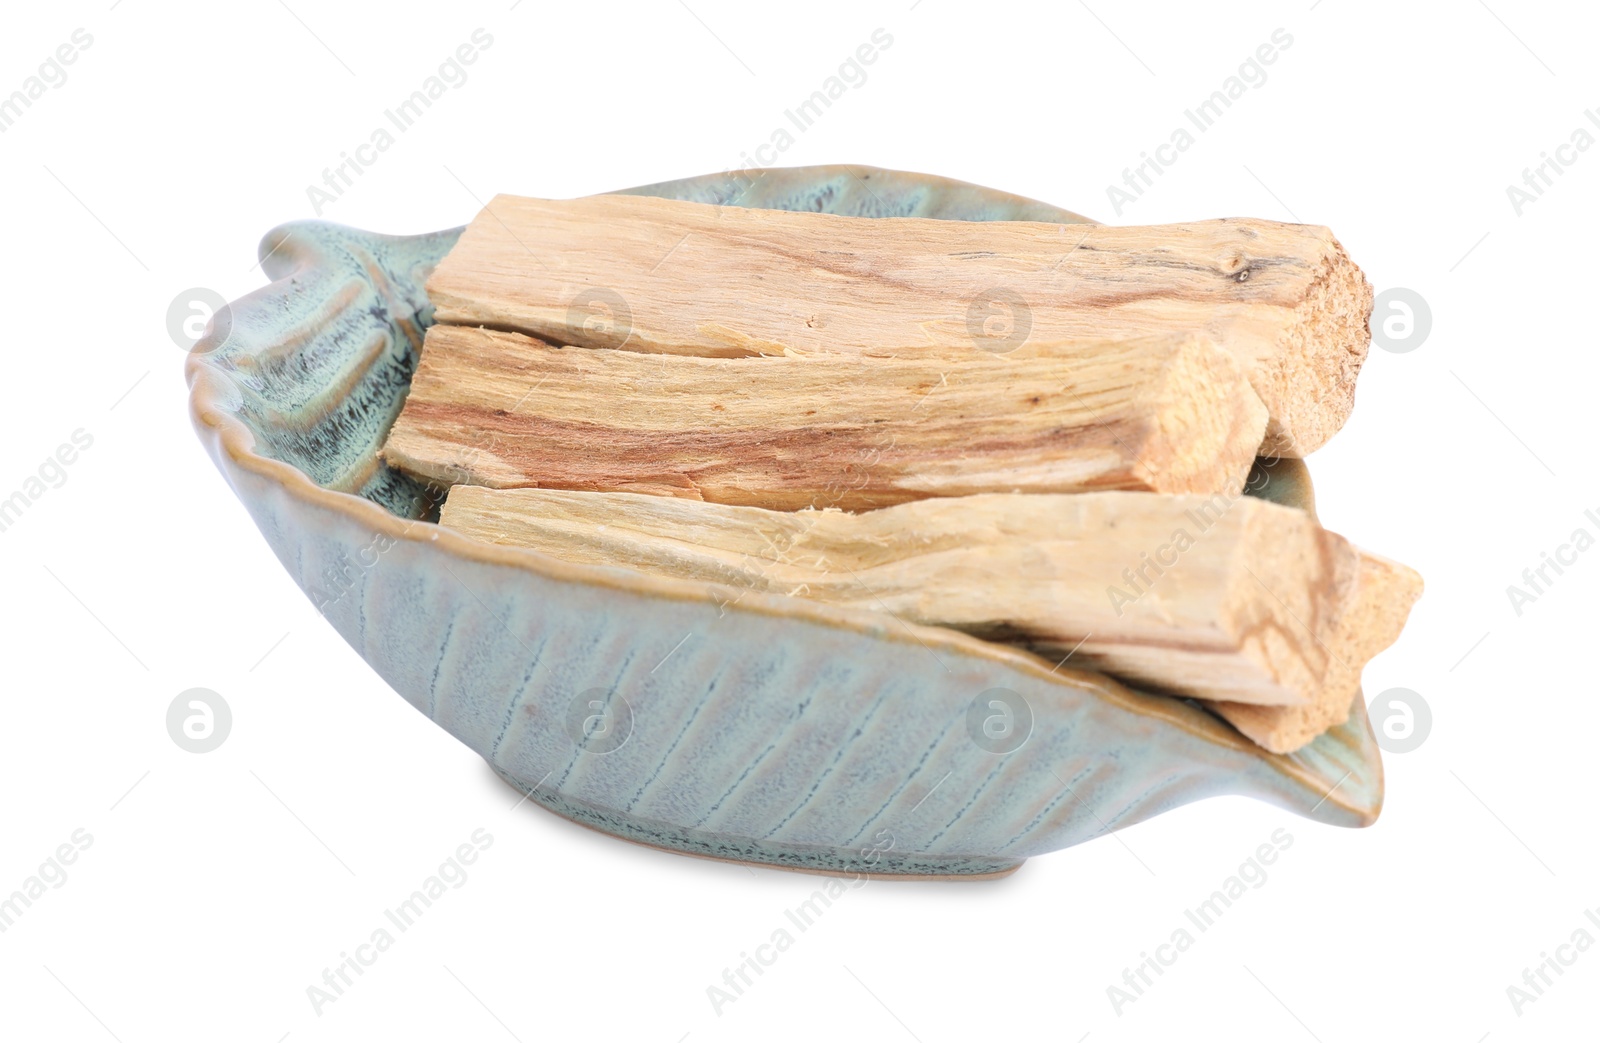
[384,325,1266,510]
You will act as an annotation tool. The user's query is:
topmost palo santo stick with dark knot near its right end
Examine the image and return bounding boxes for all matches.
[427,195,1373,456]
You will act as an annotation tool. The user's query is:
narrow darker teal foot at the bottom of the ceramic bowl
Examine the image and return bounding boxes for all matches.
[491,765,1026,880]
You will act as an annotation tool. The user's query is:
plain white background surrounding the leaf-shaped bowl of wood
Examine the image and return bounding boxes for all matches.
[0,0,1600,1043]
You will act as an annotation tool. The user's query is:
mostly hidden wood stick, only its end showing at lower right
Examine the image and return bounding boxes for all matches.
[1210,550,1422,753]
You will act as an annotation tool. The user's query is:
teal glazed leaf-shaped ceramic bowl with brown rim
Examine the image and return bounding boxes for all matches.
[189,166,1382,877]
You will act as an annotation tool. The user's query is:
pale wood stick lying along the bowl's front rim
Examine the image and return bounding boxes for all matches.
[440,486,1410,726]
